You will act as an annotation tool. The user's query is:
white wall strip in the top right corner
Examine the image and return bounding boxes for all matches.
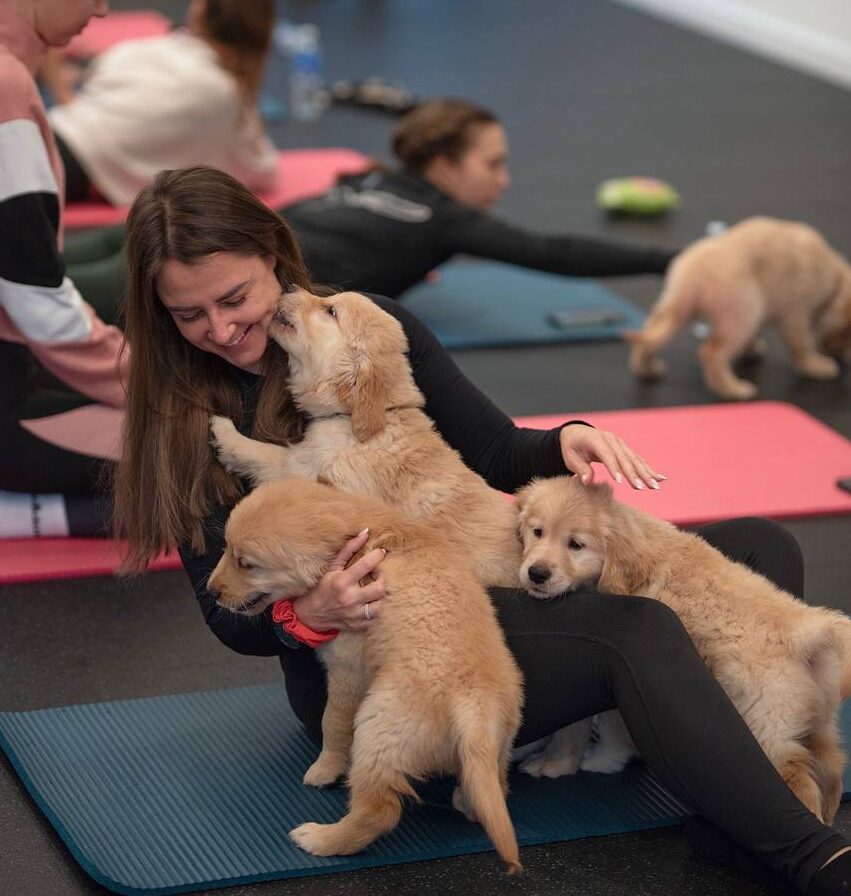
[615,0,851,88]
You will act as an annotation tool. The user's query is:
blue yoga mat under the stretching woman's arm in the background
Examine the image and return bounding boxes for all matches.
[399,261,645,349]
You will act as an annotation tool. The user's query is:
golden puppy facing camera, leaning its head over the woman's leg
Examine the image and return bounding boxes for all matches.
[518,477,851,823]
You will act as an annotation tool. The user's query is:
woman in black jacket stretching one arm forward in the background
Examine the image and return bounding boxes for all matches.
[281,99,676,298]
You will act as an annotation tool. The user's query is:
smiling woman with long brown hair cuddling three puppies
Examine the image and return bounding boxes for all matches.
[115,168,851,896]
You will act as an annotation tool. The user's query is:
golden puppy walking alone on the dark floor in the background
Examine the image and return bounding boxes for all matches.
[625,217,851,399]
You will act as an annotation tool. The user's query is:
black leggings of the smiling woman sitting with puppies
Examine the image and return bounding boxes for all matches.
[281,518,848,892]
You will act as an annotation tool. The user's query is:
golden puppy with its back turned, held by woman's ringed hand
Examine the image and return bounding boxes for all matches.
[209,479,522,873]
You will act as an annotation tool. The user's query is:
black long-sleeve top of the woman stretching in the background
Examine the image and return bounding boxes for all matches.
[281,171,676,298]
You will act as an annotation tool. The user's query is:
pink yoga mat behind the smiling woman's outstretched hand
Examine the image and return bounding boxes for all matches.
[516,401,851,525]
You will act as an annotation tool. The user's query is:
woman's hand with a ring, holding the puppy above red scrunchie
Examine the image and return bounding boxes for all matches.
[293,529,387,632]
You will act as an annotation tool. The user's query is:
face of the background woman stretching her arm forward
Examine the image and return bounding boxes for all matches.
[426,123,511,211]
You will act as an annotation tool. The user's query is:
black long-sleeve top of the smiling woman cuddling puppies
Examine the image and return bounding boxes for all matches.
[180,296,568,656]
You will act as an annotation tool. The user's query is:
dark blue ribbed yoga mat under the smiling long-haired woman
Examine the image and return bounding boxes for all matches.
[0,685,851,894]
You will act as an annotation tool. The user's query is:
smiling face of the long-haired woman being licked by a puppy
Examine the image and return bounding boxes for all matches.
[156,252,281,373]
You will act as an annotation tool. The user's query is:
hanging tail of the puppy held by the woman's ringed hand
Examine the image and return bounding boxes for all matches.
[458,711,523,874]
